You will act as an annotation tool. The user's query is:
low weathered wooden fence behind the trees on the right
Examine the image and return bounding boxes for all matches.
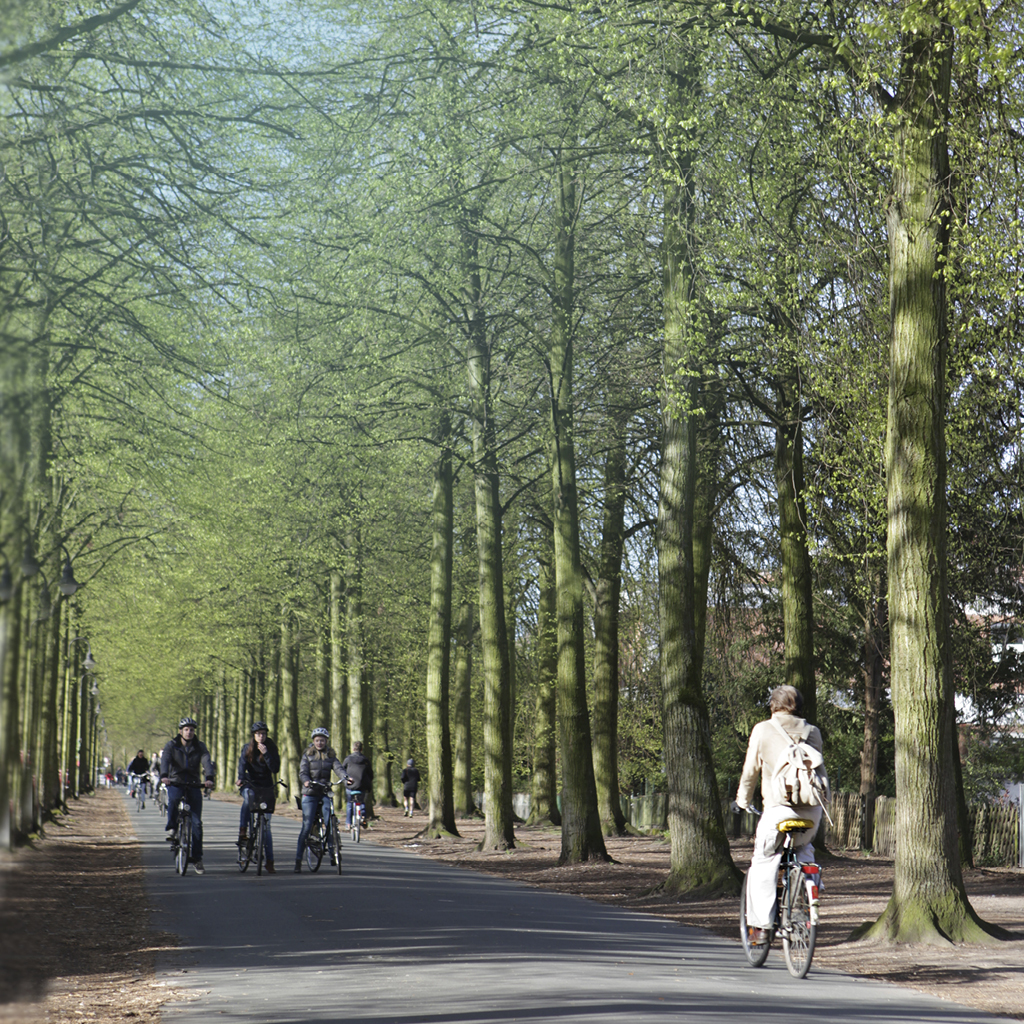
[623,793,1024,867]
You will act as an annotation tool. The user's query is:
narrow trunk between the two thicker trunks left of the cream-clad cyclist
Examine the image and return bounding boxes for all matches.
[594,412,629,836]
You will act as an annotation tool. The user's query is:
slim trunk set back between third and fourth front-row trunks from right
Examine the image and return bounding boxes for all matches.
[527,532,562,825]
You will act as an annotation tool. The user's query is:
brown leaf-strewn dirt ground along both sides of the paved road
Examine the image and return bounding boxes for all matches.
[0,790,1024,1024]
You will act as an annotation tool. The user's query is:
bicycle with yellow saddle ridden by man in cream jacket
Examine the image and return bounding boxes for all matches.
[739,818,821,978]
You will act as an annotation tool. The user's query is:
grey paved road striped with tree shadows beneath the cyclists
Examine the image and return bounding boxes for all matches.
[125,801,997,1024]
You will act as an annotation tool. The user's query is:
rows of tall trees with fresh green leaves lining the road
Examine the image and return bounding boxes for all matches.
[0,0,1024,941]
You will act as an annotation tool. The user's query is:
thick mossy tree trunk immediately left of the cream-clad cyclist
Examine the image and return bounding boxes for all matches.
[657,66,740,893]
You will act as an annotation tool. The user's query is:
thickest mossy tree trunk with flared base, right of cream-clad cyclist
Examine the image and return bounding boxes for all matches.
[869,8,998,944]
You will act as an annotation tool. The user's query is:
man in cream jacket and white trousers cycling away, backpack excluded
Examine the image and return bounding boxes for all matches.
[735,686,821,941]
